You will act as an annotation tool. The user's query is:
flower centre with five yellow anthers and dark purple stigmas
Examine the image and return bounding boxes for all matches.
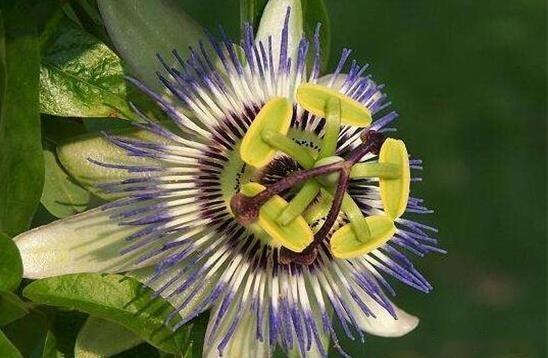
[214,84,409,264]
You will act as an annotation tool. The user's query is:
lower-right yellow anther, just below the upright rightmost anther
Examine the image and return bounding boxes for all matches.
[329,215,396,259]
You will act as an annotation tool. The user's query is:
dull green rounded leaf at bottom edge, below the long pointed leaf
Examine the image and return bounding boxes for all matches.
[74,317,143,358]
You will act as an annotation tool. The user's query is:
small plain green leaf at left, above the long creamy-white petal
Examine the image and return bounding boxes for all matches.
[40,143,90,218]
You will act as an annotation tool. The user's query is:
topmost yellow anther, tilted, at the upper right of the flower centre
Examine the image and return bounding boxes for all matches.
[297,83,372,127]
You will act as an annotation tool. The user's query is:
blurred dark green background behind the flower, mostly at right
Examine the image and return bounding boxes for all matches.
[185,0,547,357]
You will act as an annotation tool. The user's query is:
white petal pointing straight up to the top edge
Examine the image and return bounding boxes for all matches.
[256,0,303,64]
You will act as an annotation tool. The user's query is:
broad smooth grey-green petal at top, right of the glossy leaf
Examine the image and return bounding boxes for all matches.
[97,0,204,91]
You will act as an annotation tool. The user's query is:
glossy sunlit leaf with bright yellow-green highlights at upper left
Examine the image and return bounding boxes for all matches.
[40,19,133,118]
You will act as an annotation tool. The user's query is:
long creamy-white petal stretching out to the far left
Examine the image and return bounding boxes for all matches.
[14,208,151,278]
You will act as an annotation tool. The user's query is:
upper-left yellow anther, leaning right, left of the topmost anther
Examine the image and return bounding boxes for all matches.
[240,97,293,168]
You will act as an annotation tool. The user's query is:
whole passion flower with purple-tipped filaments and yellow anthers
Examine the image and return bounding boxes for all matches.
[15,2,441,357]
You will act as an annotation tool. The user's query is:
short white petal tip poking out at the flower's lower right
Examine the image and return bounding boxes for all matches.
[356,298,419,337]
